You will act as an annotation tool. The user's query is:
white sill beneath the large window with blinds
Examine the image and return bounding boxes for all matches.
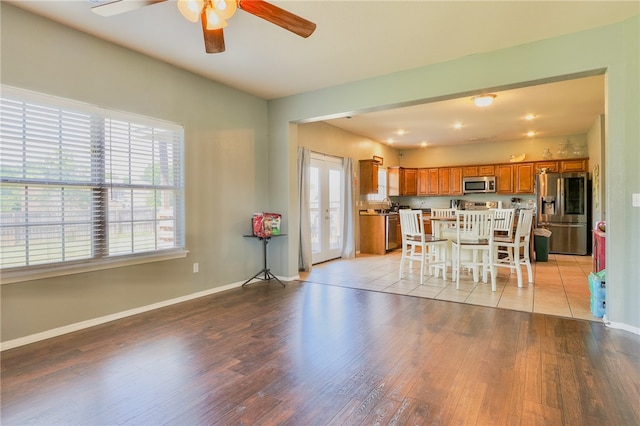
[0,250,189,284]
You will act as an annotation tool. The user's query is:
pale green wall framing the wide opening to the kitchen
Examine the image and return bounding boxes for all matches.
[269,16,640,333]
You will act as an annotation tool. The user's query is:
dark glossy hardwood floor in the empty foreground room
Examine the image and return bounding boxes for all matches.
[1,282,640,426]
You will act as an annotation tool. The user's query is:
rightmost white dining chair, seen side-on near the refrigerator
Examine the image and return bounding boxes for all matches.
[494,209,533,287]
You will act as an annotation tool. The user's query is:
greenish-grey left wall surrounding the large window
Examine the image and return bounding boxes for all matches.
[0,3,269,342]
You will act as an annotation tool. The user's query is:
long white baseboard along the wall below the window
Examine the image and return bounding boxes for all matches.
[0,282,248,352]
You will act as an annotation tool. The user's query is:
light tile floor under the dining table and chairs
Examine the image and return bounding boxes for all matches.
[300,250,601,321]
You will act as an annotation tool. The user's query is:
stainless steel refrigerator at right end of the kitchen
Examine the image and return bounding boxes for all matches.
[536,173,590,254]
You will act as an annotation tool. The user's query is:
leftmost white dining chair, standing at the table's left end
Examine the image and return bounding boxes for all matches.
[398,209,447,285]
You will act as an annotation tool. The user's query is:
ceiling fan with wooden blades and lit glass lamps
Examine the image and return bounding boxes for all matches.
[89,0,316,53]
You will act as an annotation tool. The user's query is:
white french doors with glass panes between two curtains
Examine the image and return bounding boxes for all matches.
[309,153,344,264]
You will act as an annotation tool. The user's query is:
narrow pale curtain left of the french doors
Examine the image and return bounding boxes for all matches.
[298,146,312,271]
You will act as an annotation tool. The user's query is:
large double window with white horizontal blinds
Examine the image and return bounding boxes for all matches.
[0,87,184,270]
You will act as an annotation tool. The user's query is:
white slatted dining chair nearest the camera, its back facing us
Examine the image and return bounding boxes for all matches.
[451,210,496,291]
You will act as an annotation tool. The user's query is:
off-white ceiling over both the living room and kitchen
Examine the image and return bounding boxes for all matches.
[3,0,640,148]
